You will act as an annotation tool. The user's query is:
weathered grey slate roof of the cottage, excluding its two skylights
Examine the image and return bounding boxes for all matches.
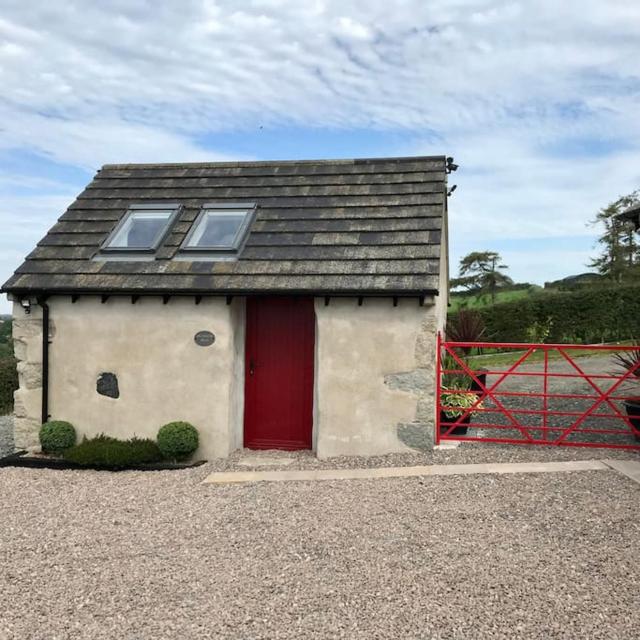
[3,156,446,295]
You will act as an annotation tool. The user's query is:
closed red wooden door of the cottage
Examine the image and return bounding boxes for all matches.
[244,297,315,450]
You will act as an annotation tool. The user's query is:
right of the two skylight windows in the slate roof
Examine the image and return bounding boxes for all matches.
[182,203,255,252]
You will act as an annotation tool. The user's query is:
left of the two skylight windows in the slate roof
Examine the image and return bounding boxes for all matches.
[102,204,179,252]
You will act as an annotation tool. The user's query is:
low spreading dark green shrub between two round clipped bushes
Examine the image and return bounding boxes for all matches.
[63,434,162,469]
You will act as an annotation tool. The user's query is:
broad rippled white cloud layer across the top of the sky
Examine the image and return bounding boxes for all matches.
[0,0,640,133]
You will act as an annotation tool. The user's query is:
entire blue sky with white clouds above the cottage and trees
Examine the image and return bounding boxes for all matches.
[0,0,640,312]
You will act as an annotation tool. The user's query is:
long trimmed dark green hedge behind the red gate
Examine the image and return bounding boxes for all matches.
[452,286,640,344]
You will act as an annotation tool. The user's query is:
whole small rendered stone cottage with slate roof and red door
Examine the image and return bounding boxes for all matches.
[2,156,455,458]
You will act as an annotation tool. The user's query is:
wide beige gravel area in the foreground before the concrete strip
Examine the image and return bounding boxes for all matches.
[0,465,640,640]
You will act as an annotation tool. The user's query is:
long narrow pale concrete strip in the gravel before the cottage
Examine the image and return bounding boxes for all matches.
[203,460,608,484]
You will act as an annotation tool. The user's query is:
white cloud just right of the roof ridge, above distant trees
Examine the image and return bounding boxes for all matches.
[424,129,640,244]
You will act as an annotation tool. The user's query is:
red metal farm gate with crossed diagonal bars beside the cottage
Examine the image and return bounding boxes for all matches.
[435,336,640,450]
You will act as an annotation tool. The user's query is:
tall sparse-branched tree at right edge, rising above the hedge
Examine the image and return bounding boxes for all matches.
[589,191,640,283]
